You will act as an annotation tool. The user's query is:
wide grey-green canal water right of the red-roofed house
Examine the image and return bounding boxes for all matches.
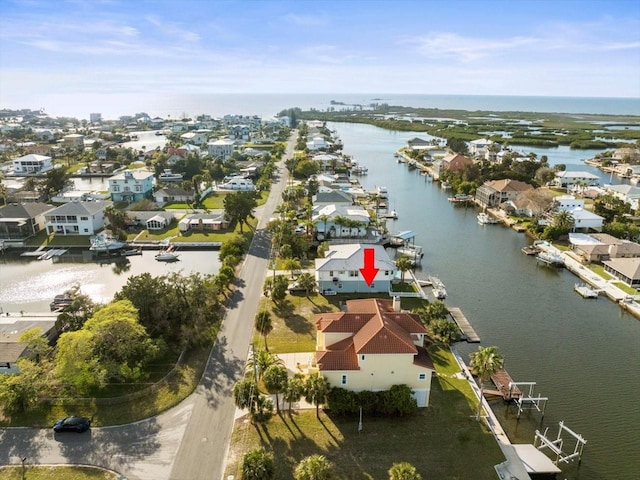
[331,123,640,480]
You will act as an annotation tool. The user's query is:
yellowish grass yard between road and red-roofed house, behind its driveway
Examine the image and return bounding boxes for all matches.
[253,293,340,353]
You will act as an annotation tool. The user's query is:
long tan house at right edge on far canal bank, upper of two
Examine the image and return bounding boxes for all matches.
[569,233,640,263]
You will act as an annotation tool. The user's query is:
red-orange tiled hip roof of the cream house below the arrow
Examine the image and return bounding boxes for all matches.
[316,298,427,370]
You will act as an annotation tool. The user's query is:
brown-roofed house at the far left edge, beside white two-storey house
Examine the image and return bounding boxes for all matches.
[0,202,54,241]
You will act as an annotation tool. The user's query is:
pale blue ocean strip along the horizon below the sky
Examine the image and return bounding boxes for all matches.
[6,93,640,120]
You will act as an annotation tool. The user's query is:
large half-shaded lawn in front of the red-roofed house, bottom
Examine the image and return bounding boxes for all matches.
[225,378,504,480]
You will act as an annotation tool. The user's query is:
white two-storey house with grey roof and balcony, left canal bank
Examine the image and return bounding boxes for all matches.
[45,202,111,235]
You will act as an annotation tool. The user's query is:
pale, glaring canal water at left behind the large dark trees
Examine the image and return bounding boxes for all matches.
[0,250,220,312]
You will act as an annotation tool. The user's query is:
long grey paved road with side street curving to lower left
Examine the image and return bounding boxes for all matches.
[0,131,297,480]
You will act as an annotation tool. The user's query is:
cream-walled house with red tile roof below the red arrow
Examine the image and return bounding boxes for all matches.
[315,298,434,407]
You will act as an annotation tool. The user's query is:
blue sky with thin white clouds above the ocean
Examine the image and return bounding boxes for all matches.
[0,0,640,117]
